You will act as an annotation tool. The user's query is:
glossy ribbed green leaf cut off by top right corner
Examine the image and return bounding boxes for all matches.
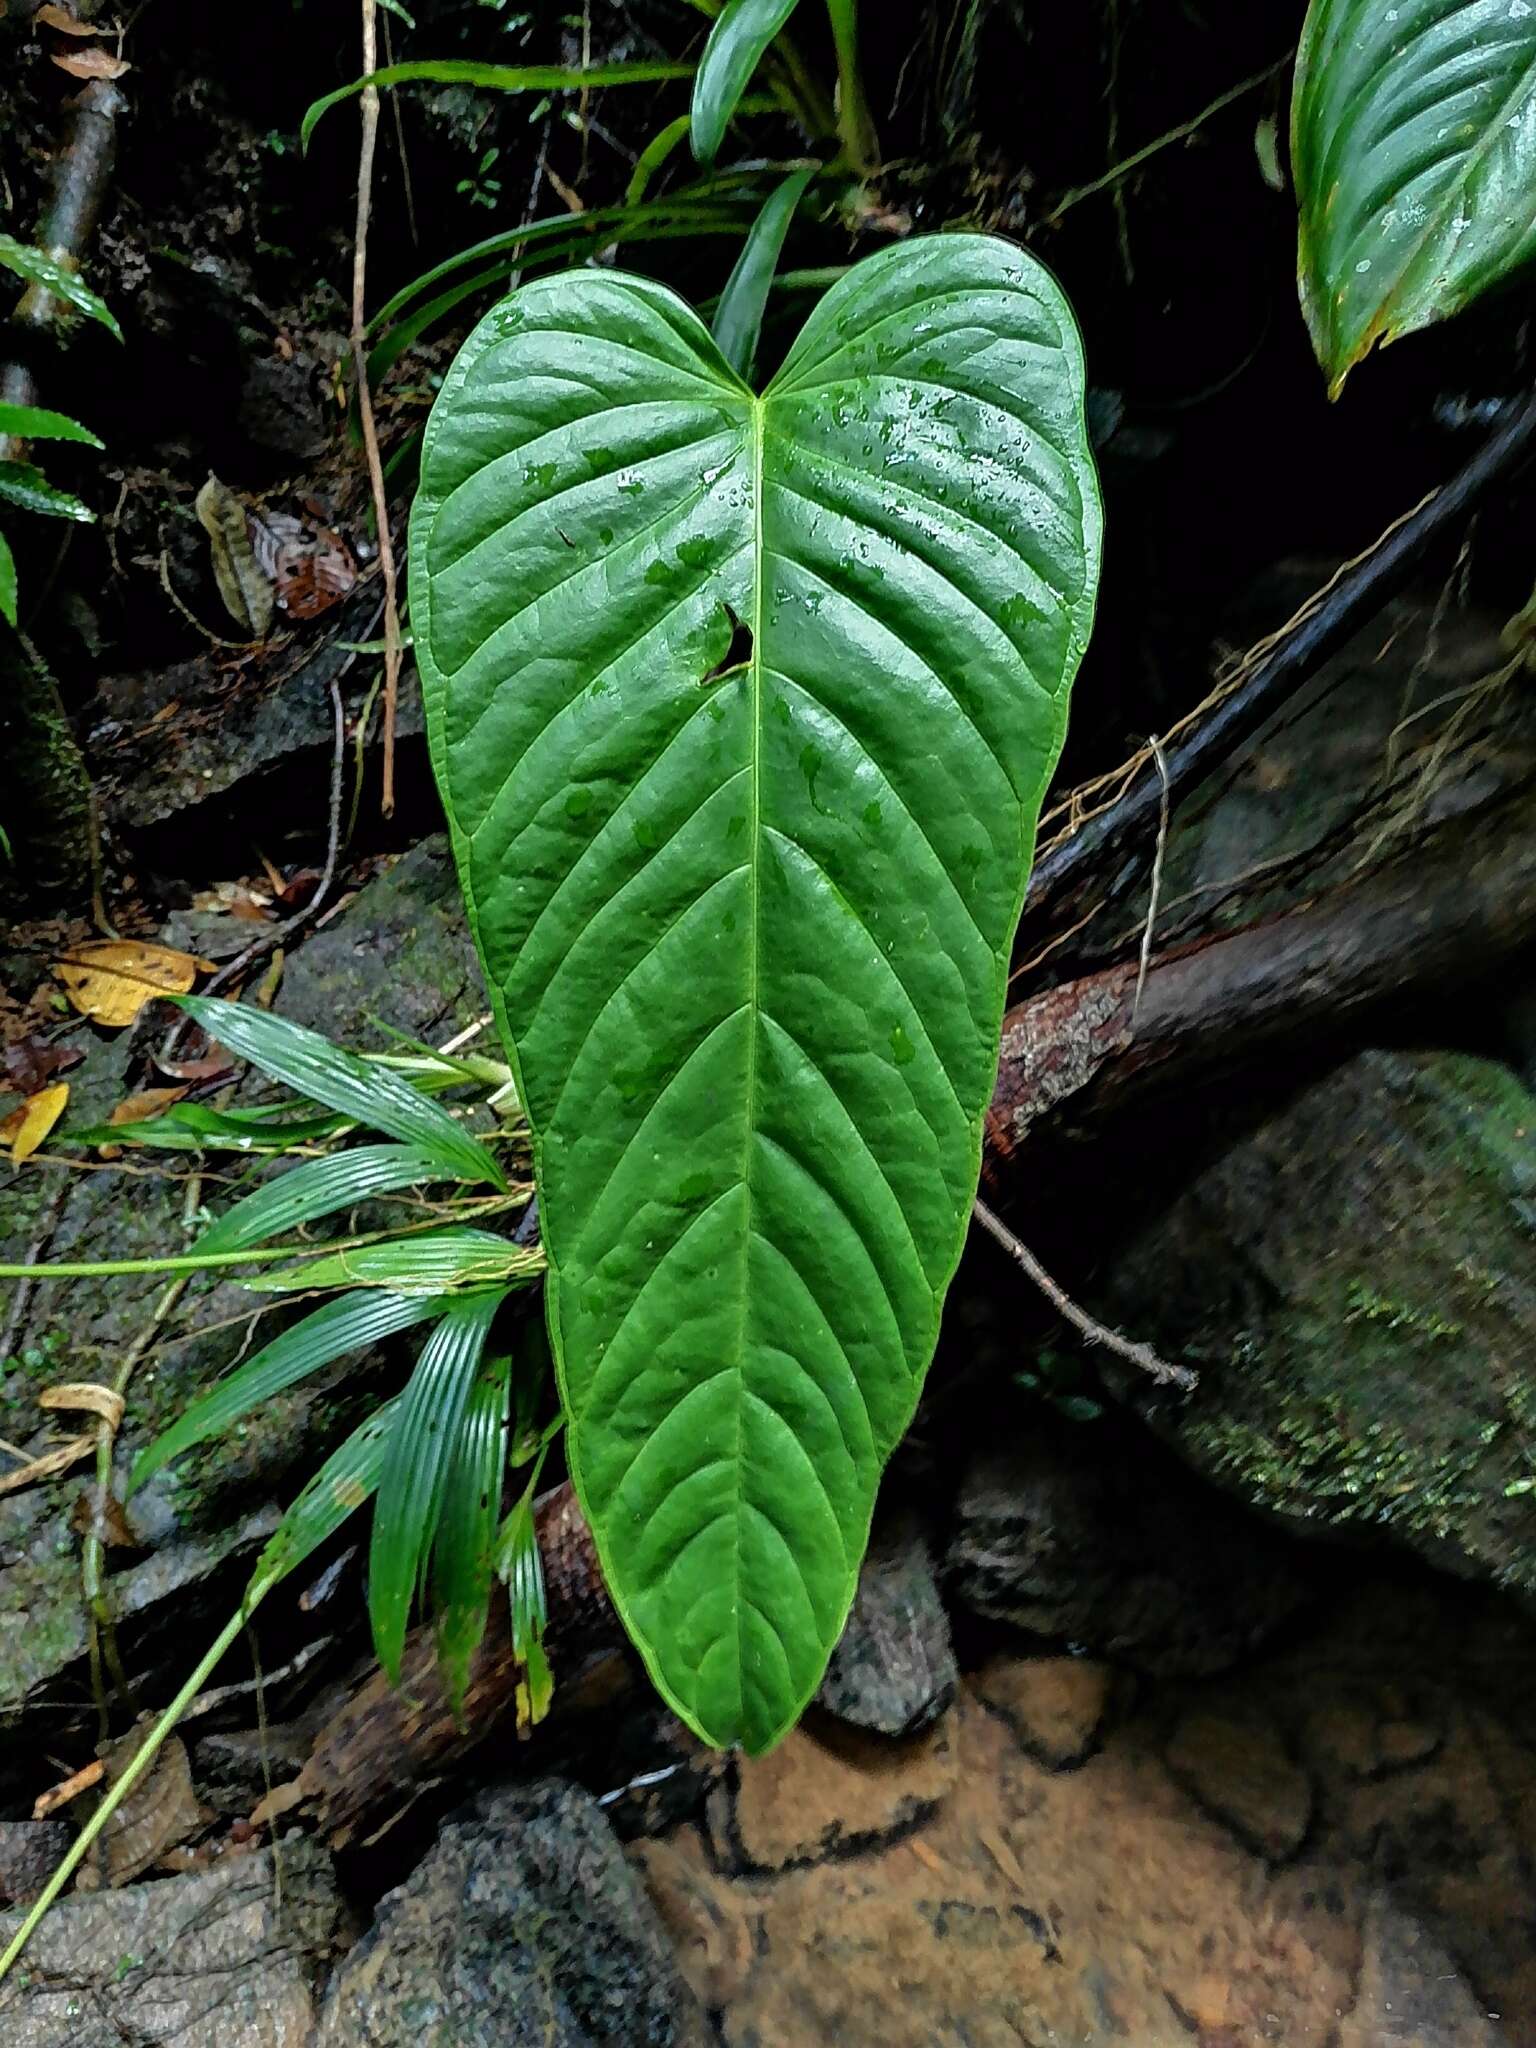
[1292,0,1536,395]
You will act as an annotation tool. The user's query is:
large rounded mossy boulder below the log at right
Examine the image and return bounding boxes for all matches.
[1098,1051,1536,1599]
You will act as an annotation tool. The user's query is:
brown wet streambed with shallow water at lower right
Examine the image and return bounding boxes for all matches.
[631,1581,1536,2048]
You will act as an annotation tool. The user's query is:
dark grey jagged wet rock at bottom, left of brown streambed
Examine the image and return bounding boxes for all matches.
[313,1780,709,2048]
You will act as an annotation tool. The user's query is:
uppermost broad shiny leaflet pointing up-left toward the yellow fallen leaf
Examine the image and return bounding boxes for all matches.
[176,995,506,1188]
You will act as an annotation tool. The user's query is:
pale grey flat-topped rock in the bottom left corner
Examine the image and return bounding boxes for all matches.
[0,1839,346,2048]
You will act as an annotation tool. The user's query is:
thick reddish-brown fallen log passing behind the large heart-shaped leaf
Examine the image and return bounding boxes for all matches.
[258,770,1536,1847]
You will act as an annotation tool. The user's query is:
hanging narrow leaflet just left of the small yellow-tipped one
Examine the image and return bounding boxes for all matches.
[432,1352,512,1712]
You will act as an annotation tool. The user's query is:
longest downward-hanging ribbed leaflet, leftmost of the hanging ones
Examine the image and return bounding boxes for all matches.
[369,1288,504,1681]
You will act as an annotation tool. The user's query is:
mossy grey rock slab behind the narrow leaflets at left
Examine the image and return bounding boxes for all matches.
[0,840,483,1753]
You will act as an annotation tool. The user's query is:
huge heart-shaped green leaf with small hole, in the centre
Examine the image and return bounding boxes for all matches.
[412,236,1100,1751]
